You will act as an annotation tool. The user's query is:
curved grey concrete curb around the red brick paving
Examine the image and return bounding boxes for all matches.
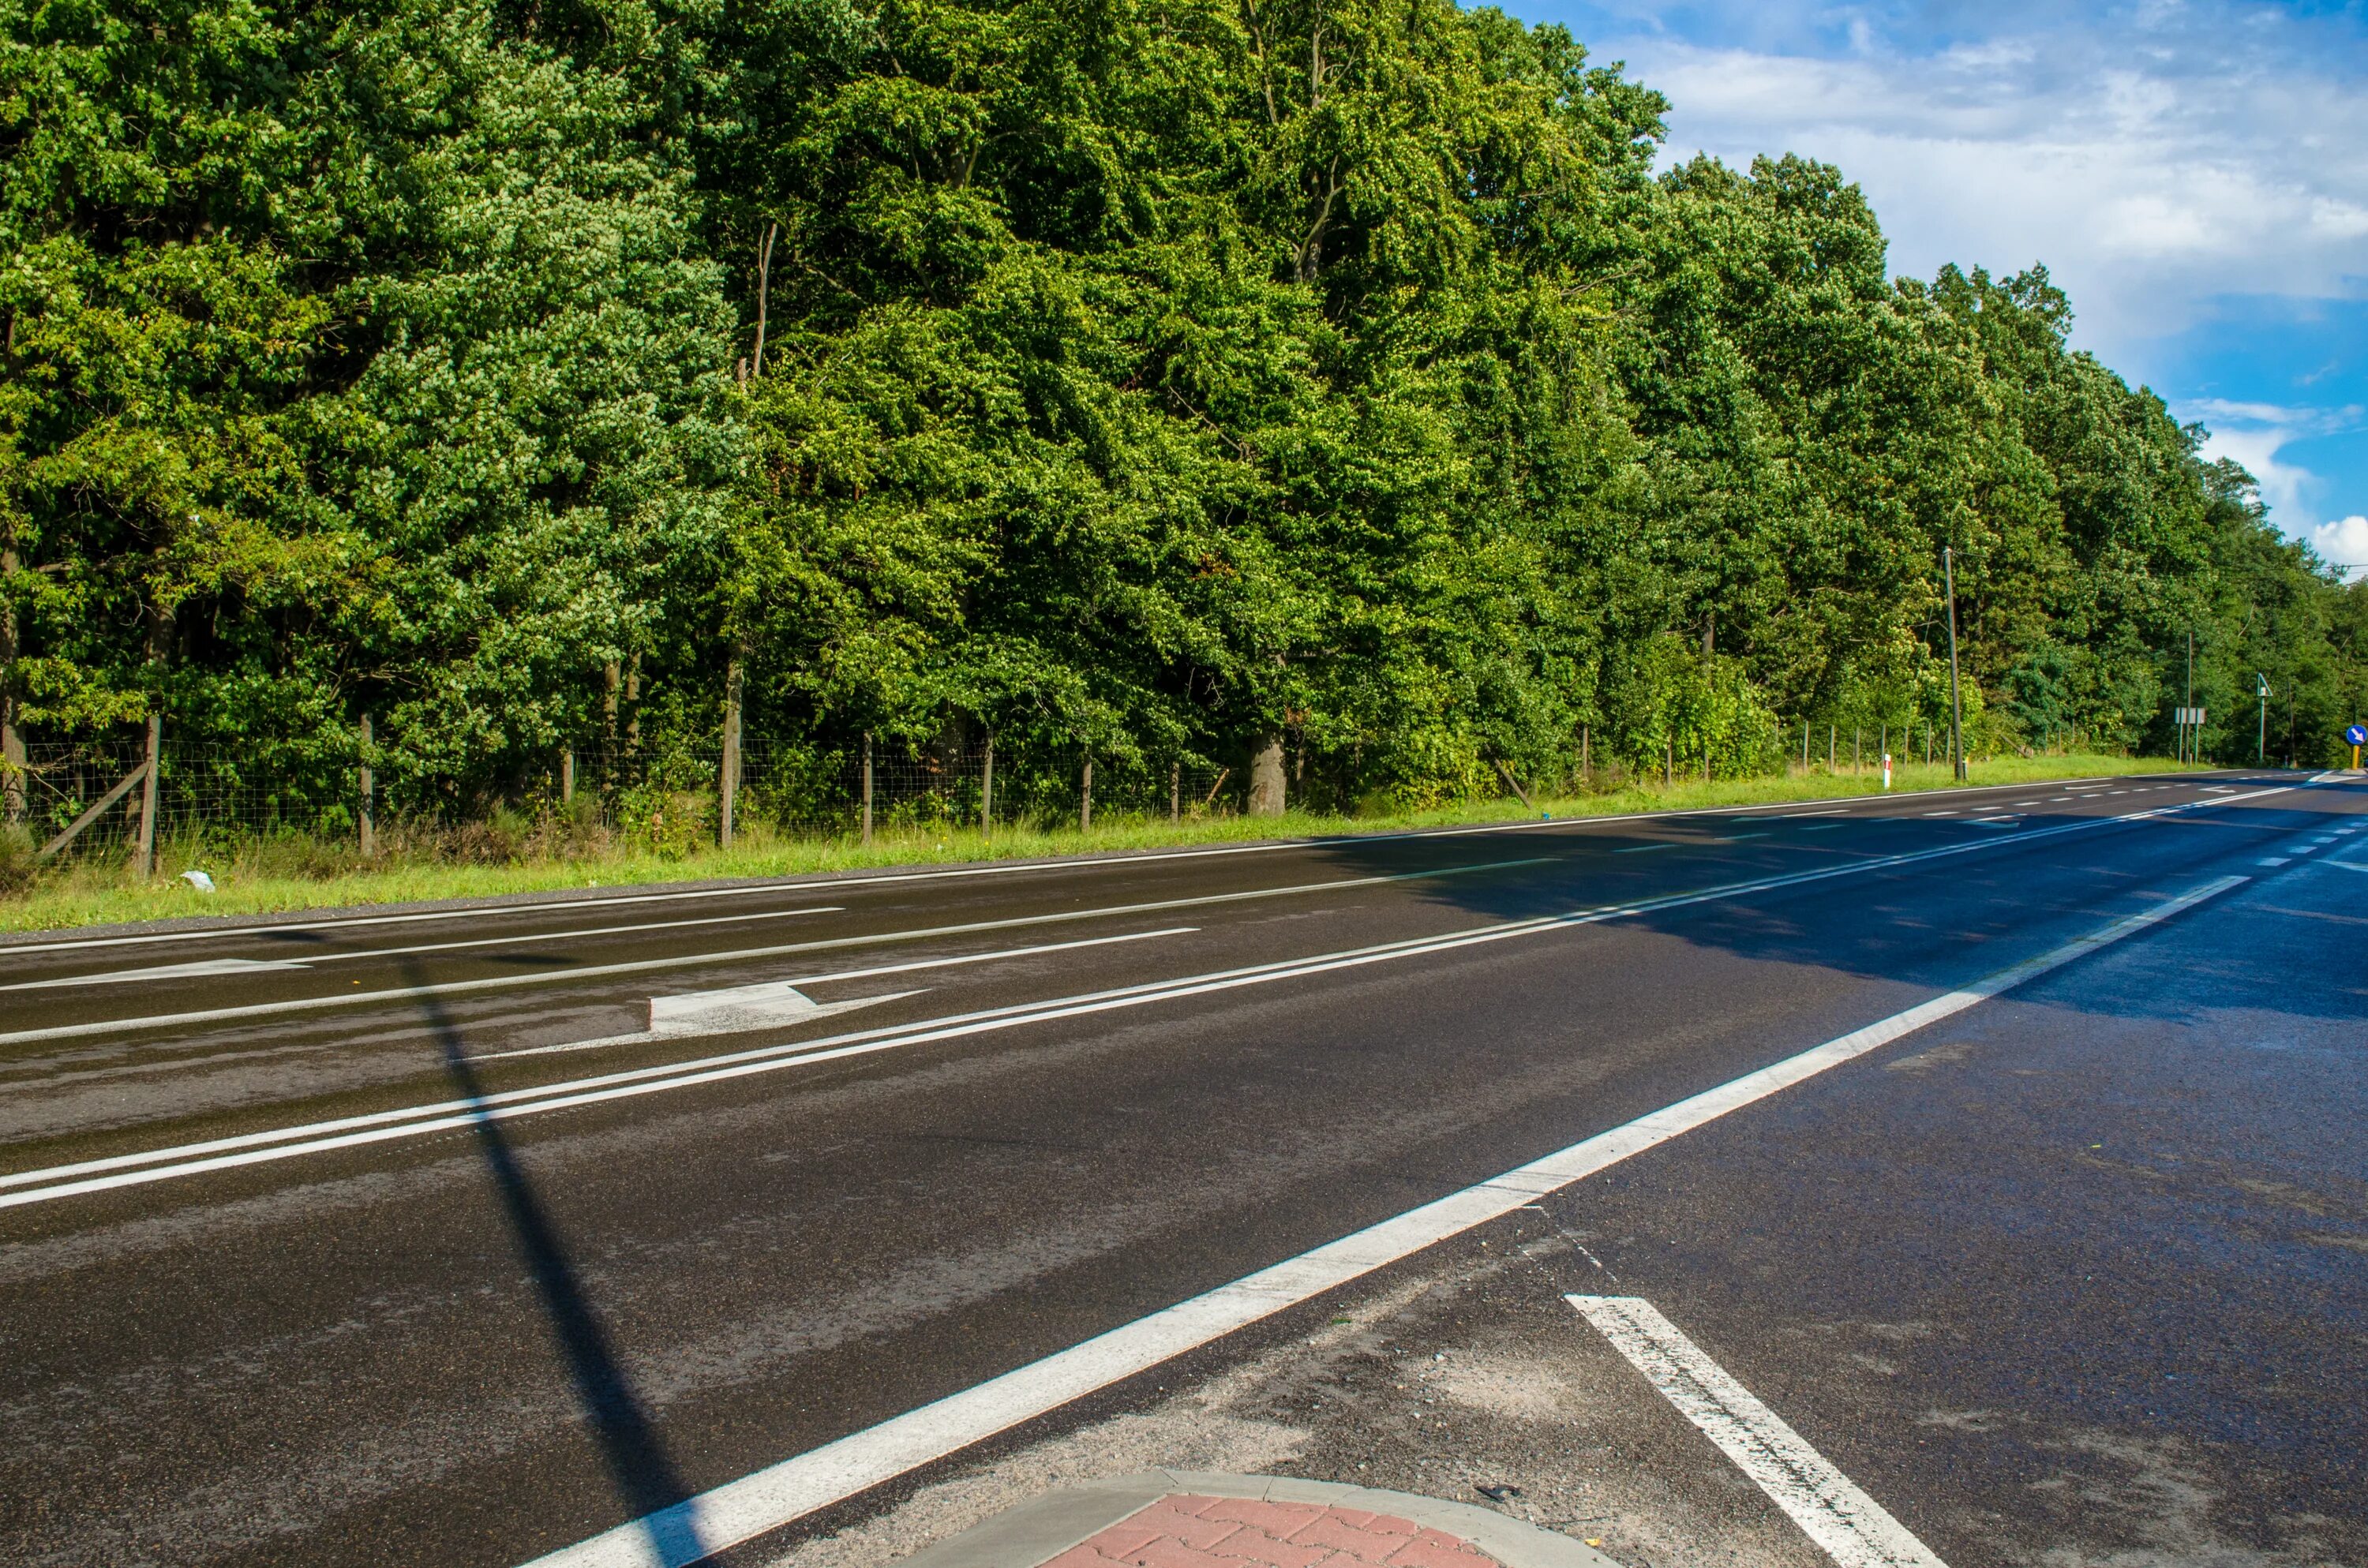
[905,1469,1620,1568]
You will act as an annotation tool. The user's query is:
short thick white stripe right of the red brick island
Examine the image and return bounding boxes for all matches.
[1563,1296,1949,1568]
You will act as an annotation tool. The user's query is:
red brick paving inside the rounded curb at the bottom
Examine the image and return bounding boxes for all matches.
[1042,1497,1504,1568]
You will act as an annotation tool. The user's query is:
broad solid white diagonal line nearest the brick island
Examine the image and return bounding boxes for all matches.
[509,877,2245,1568]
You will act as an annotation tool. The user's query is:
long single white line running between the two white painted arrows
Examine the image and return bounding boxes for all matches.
[0,855,1551,1045]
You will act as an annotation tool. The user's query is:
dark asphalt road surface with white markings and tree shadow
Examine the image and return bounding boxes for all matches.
[0,774,2368,1568]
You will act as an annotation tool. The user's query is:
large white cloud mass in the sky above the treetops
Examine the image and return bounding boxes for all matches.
[1589,5,2368,360]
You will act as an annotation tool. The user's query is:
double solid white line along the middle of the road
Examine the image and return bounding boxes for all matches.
[0,791,2278,1208]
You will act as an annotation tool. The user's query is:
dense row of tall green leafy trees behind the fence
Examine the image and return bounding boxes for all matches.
[0,0,2368,824]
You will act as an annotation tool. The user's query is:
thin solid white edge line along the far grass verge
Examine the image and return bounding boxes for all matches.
[0,767,2254,960]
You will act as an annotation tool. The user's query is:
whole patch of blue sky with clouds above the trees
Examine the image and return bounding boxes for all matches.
[1499,0,2368,578]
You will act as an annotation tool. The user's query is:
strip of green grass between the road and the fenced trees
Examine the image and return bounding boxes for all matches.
[0,755,2216,931]
